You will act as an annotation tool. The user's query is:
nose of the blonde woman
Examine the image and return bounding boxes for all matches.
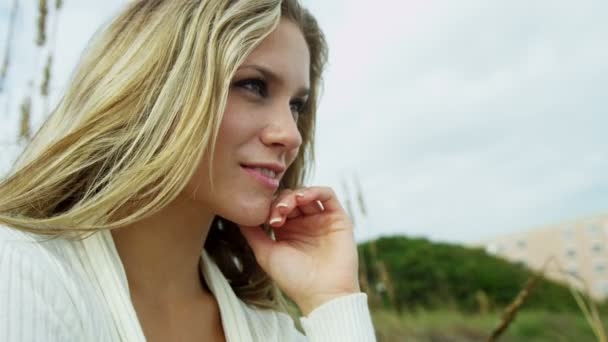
[261,104,302,151]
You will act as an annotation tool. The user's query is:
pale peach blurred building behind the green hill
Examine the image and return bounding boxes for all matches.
[480,213,608,299]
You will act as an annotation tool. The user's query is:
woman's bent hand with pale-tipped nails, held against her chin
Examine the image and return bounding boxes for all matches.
[240,187,361,316]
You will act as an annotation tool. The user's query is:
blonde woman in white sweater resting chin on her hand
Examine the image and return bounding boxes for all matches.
[0,0,374,341]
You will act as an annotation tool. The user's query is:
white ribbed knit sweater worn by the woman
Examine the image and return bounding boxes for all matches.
[0,226,376,342]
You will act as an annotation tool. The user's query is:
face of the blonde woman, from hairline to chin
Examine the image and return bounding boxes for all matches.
[187,19,310,226]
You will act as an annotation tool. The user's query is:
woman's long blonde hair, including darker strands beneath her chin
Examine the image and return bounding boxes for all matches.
[0,0,327,311]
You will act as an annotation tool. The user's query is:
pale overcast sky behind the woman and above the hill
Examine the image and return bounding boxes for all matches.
[0,0,608,242]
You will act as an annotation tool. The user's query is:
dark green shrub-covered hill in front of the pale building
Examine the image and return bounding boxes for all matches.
[359,236,604,313]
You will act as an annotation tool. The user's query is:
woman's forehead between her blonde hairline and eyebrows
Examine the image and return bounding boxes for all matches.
[243,19,310,87]
